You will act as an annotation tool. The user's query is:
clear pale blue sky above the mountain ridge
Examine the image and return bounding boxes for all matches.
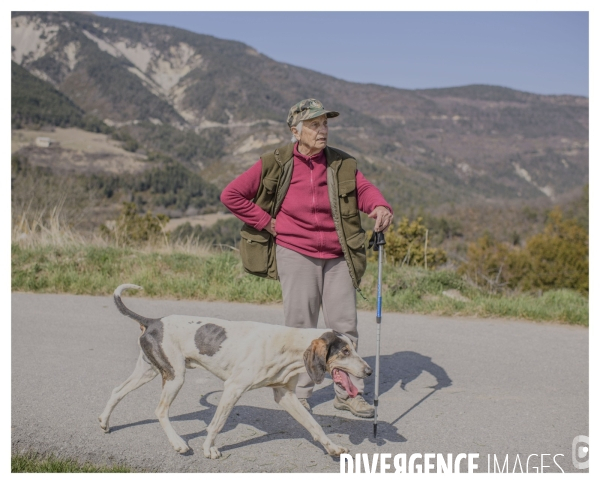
[95,12,589,96]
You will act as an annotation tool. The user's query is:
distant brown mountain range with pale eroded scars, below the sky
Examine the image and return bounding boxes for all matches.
[12,12,589,212]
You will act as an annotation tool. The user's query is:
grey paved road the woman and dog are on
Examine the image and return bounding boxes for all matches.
[12,293,589,472]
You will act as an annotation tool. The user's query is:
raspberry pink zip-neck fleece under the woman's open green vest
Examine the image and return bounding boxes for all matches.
[221,143,392,259]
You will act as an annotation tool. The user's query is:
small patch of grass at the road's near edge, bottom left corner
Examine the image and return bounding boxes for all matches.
[10,452,134,473]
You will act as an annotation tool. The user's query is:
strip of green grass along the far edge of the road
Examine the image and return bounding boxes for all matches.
[11,243,589,326]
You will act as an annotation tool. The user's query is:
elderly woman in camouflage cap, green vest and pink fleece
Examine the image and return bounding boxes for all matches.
[221,99,393,417]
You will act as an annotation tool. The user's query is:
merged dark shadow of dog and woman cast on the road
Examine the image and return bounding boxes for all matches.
[106,351,452,451]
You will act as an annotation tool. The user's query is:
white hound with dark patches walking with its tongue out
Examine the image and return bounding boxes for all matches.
[98,284,372,459]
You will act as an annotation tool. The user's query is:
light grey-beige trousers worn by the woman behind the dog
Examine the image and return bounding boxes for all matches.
[276,245,364,398]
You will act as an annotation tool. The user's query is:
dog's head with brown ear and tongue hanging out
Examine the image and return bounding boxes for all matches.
[304,331,373,396]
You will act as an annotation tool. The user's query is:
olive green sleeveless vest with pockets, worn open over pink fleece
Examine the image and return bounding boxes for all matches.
[240,143,367,289]
